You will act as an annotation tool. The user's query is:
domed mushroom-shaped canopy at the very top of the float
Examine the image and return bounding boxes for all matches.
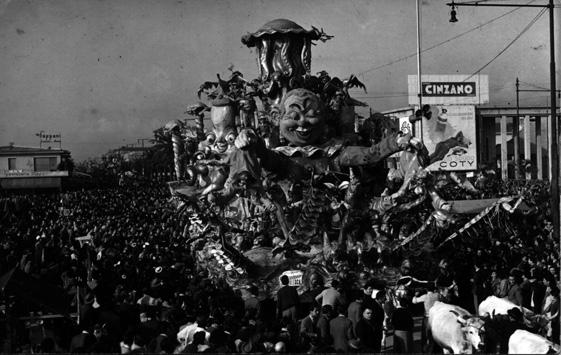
[242,19,322,47]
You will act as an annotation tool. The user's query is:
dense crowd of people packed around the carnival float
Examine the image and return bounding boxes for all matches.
[0,177,559,353]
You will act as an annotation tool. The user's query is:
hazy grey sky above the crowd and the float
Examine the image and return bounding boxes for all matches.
[0,0,561,161]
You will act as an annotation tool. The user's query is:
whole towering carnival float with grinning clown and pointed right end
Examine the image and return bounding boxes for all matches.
[161,19,532,300]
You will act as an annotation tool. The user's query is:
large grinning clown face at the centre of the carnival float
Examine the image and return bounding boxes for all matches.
[279,89,325,146]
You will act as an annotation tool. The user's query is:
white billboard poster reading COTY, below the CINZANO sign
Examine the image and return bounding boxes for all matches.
[423,105,477,171]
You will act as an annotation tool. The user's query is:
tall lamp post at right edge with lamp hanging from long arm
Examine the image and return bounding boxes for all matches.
[446,0,560,239]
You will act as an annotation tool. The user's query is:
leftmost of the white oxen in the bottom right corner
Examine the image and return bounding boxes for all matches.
[429,301,485,354]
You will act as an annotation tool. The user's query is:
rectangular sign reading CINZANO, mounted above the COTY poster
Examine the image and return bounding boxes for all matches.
[407,75,489,105]
